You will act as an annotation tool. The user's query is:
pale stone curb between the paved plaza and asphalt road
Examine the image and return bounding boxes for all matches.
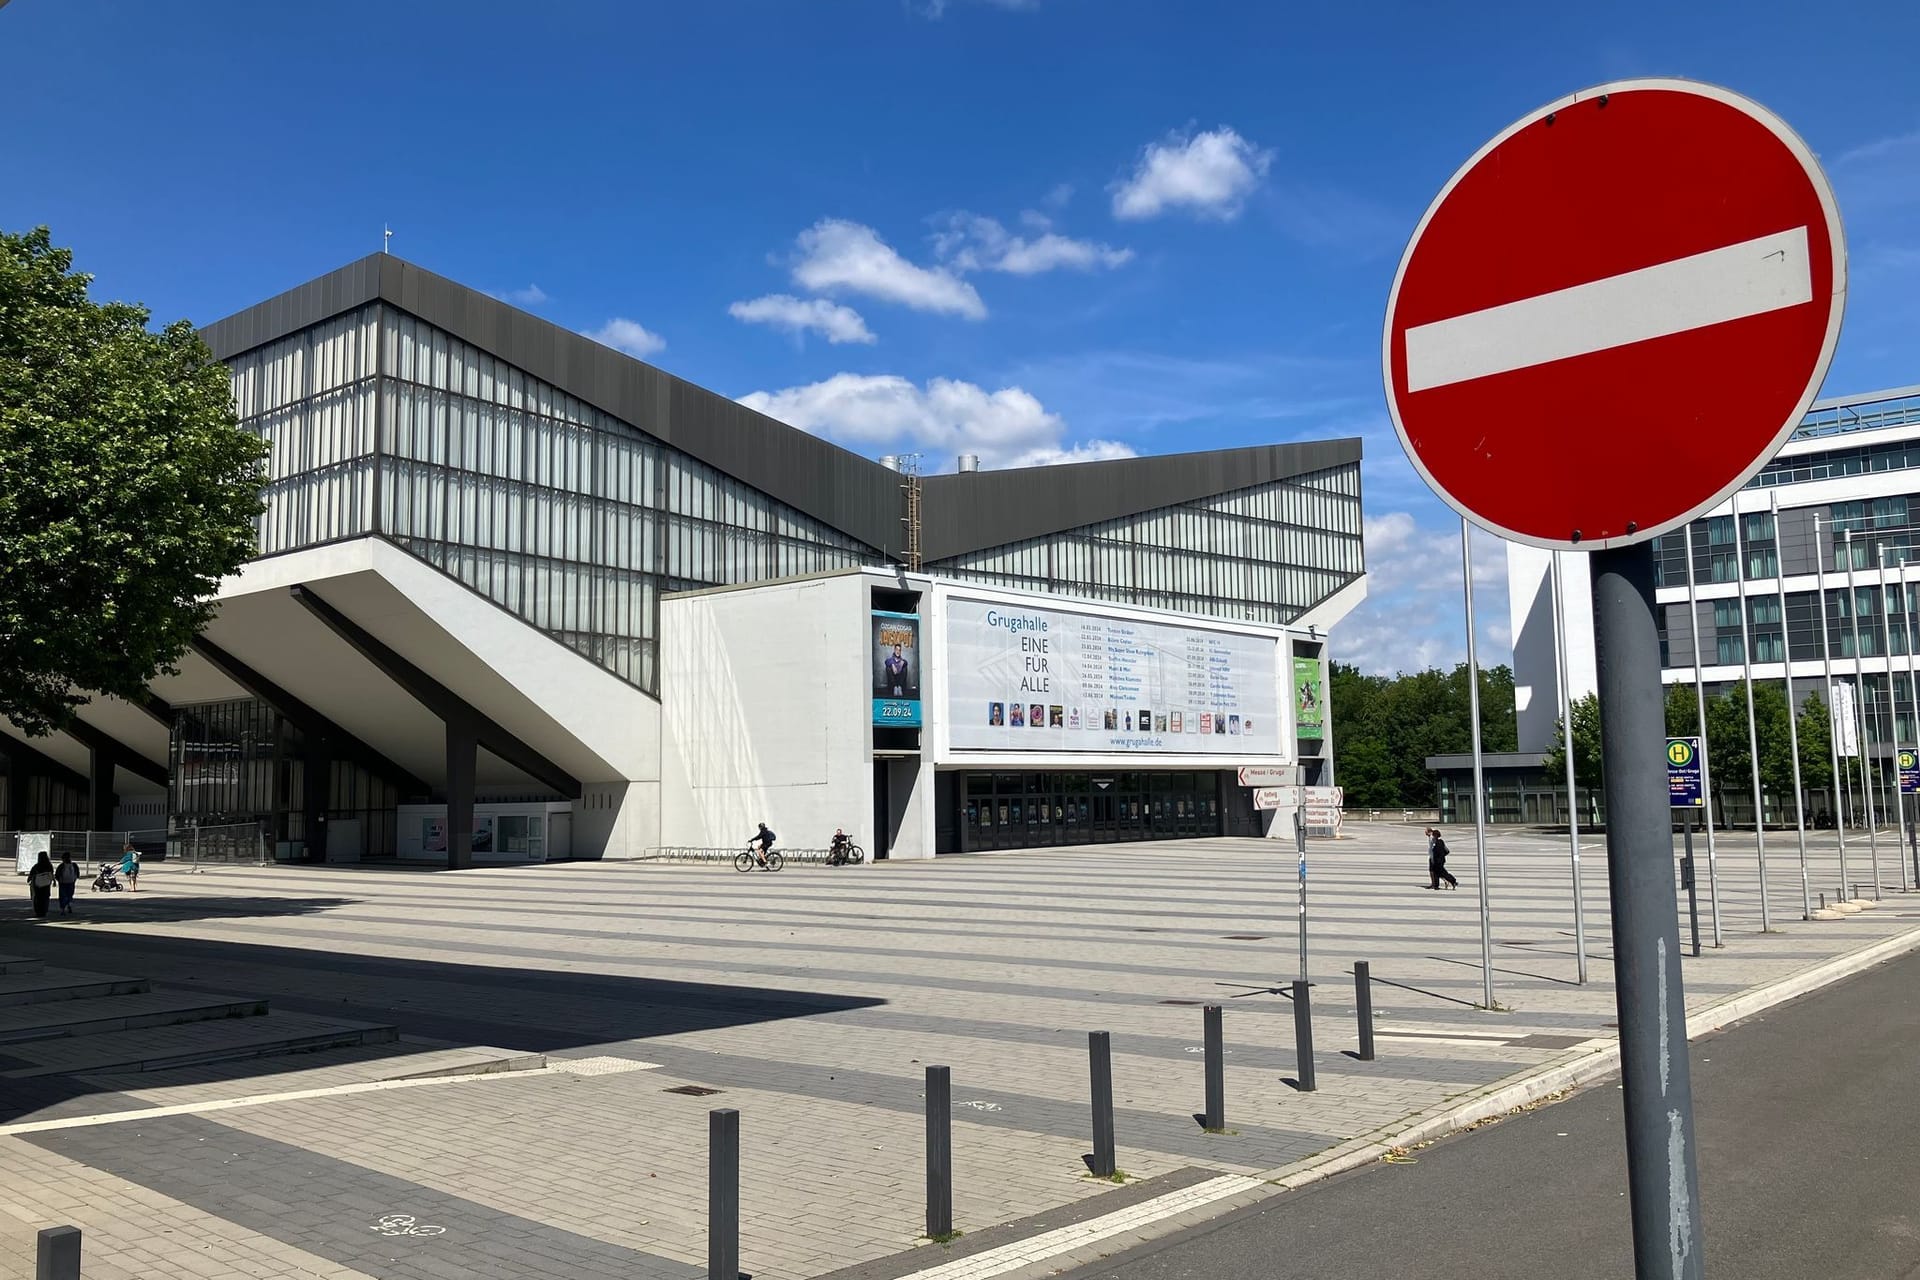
[967,929,1920,1280]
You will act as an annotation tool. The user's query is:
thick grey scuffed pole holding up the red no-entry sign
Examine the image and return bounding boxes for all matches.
[1592,543,1705,1280]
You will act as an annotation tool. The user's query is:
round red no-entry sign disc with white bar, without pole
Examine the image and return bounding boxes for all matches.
[1382,81,1847,549]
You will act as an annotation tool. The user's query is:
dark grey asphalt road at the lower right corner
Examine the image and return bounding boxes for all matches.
[1073,940,1920,1280]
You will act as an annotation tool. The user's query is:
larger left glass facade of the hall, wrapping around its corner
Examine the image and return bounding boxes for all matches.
[230,305,885,693]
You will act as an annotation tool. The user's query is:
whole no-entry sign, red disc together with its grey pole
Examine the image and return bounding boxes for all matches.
[1382,81,1847,1280]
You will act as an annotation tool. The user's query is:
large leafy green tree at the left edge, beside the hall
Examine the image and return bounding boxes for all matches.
[0,226,265,735]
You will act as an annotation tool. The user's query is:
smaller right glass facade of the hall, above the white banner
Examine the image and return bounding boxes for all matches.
[927,466,1365,622]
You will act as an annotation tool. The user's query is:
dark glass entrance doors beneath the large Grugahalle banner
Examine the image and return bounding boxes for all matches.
[954,770,1221,852]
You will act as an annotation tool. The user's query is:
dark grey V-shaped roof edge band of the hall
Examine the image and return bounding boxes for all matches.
[202,253,1361,560]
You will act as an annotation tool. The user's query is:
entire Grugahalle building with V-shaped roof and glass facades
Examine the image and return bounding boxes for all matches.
[0,253,1365,865]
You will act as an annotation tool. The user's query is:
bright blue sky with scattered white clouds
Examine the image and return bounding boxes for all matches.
[0,0,1920,670]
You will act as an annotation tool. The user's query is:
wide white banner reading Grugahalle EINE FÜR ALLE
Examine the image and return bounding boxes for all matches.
[945,599,1281,756]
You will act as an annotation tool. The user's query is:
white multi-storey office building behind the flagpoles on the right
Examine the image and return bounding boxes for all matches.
[1497,386,1920,821]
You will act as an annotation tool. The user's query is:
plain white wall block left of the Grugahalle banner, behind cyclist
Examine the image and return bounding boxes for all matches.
[660,574,871,854]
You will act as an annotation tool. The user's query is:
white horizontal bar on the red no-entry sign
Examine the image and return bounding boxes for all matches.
[1405,226,1812,391]
